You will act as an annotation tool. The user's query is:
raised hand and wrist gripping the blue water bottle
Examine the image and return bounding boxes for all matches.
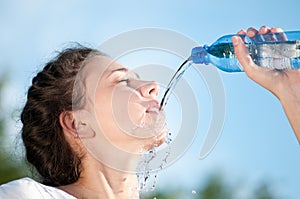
[232,26,300,143]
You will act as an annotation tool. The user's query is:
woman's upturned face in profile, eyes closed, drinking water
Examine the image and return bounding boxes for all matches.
[81,56,166,153]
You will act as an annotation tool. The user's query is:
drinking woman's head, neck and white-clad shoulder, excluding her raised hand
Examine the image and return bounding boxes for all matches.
[0,47,166,198]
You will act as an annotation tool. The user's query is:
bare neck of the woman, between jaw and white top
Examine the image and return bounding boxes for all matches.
[59,153,139,199]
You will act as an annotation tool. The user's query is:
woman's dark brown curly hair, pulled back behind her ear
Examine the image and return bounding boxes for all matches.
[21,46,104,186]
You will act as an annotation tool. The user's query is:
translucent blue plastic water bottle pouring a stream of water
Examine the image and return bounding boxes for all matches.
[190,31,300,72]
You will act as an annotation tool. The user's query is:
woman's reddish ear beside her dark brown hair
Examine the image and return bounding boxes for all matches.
[59,111,78,137]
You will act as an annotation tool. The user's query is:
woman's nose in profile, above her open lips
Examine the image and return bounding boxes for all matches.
[132,81,159,99]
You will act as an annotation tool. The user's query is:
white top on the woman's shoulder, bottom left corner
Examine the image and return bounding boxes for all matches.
[0,178,75,199]
